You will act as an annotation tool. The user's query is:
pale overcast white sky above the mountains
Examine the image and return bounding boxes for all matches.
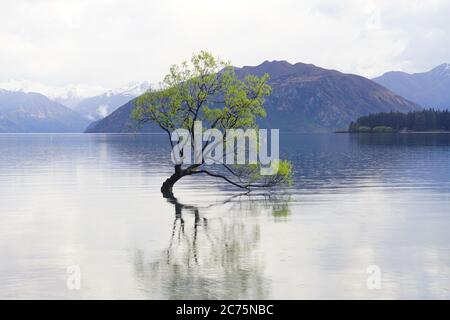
[0,0,450,94]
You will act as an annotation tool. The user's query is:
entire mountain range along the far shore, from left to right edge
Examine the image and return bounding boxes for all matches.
[4,61,450,133]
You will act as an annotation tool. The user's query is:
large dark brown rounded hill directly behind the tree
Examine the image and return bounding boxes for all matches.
[87,61,421,132]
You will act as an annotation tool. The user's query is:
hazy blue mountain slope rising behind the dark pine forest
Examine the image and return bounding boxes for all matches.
[373,63,450,109]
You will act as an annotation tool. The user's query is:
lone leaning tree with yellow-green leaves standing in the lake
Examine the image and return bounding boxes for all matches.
[132,51,292,195]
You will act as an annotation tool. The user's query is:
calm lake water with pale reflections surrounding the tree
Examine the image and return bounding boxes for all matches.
[0,134,450,299]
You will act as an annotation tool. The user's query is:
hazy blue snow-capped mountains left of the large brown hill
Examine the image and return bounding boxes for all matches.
[0,82,150,133]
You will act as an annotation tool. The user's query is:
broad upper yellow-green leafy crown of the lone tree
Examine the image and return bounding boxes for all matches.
[132,51,271,132]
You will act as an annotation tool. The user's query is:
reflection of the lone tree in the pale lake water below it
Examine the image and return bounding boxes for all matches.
[134,195,289,299]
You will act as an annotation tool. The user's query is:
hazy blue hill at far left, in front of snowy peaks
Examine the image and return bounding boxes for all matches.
[0,89,89,133]
